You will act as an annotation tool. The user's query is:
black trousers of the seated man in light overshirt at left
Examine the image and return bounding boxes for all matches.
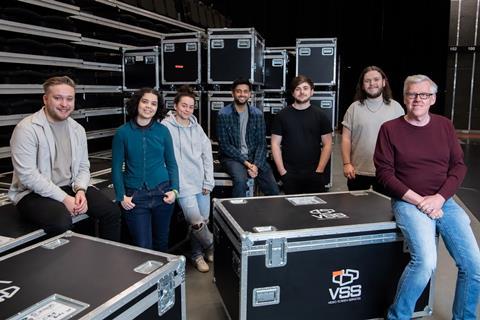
[17,186,120,241]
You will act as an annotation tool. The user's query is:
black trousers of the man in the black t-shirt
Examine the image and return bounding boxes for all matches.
[281,169,326,194]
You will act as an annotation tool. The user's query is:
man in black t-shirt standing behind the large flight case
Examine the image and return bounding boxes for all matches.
[272,75,332,194]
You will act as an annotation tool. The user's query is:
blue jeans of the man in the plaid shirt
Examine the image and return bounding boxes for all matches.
[221,158,280,198]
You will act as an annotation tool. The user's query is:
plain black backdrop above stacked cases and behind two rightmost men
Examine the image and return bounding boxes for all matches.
[213,0,450,127]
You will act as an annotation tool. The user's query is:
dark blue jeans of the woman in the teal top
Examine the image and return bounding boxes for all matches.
[122,182,173,252]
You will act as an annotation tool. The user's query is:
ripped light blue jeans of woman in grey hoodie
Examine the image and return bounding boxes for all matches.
[178,193,213,261]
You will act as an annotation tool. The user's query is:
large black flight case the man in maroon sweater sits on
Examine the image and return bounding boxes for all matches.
[213,191,433,320]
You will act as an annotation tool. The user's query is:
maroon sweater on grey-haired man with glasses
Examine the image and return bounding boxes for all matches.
[374,114,467,199]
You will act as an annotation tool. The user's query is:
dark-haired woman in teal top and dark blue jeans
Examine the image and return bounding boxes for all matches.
[112,88,178,251]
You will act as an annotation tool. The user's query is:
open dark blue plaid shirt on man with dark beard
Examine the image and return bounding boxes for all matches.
[217,104,267,170]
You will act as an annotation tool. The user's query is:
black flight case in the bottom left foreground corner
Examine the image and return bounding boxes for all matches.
[0,231,186,320]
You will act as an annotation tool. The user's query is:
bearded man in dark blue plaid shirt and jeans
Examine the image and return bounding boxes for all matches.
[217,79,279,197]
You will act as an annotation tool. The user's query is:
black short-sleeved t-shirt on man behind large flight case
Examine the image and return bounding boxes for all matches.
[272,105,332,171]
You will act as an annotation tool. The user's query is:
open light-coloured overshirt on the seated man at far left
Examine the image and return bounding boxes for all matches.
[8,107,90,204]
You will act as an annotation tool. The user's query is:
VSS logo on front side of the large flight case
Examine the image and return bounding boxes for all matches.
[328,269,362,304]
